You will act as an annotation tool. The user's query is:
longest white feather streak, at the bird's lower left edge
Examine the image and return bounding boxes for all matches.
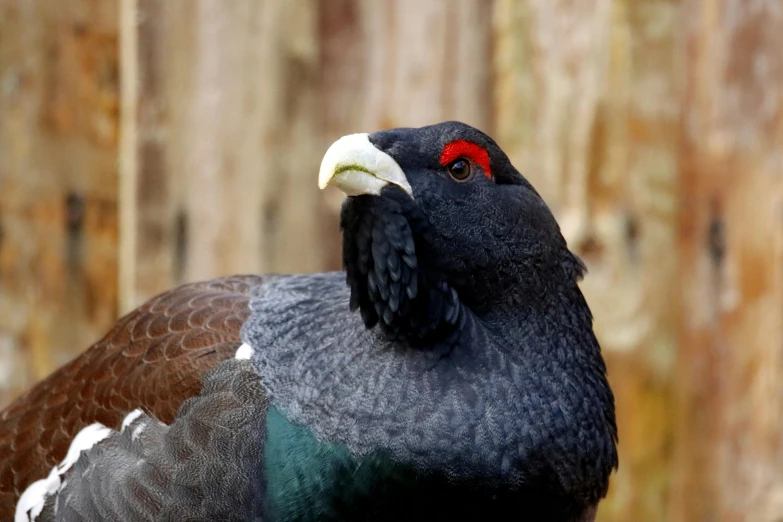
[14,422,111,522]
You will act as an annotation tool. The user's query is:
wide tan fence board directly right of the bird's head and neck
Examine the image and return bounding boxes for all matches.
[494,0,680,521]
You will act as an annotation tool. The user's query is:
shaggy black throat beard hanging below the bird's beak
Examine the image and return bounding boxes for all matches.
[341,191,465,346]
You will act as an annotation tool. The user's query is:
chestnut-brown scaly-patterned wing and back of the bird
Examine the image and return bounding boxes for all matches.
[0,276,265,520]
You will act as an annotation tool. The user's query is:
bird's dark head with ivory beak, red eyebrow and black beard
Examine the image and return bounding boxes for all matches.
[319,122,583,343]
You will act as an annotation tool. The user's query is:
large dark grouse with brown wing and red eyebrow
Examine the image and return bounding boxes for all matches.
[0,121,618,522]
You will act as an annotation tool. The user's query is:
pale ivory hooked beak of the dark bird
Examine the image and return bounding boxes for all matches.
[318,133,413,197]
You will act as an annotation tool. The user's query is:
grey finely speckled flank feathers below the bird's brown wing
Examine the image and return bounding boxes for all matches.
[31,359,267,522]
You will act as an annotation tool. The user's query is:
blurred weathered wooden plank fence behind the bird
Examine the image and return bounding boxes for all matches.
[0,0,783,522]
